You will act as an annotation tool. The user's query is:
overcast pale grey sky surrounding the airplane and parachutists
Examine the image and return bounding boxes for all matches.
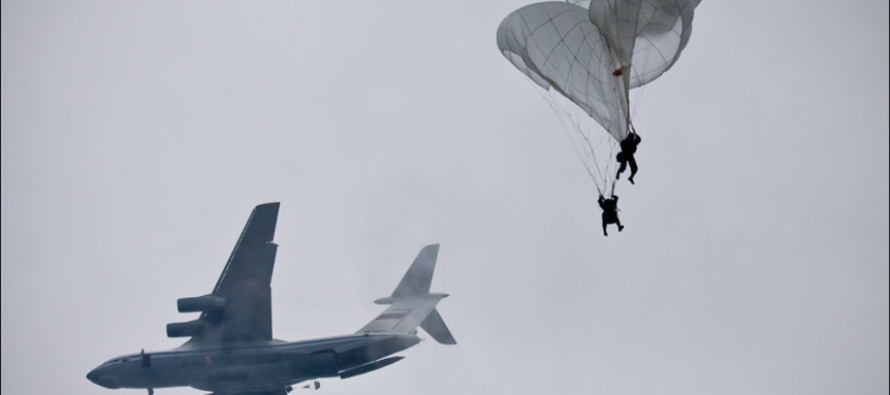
[2,0,890,395]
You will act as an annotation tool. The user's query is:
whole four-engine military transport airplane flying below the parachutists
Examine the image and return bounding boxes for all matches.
[87,203,456,395]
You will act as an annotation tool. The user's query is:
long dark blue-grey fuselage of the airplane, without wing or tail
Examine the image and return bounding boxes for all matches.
[87,334,420,391]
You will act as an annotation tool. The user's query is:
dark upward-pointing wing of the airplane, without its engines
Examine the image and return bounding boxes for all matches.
[177,202,280,346]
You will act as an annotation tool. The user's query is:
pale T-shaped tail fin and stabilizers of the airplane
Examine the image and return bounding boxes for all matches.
[356,244,457,344]
